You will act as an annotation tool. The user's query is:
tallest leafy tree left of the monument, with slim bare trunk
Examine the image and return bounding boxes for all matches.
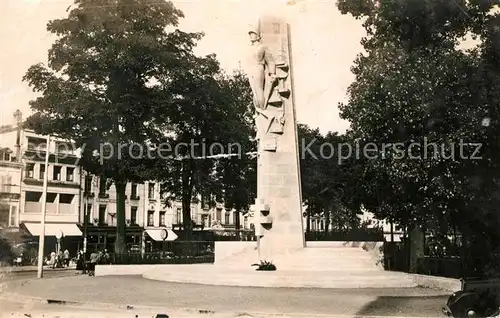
[24,0,209,252]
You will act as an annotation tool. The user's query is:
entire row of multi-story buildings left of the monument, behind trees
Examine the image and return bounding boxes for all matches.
[0,112,254,250]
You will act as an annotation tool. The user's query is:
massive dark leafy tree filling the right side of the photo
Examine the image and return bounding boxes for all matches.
[338,0,500,274]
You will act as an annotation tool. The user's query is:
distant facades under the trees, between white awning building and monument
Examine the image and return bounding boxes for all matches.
[80,178,254,252]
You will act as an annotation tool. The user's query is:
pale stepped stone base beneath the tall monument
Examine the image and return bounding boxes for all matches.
[142,242,417,289]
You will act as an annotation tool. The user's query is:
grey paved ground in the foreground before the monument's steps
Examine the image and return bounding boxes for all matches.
[1,276,447,317]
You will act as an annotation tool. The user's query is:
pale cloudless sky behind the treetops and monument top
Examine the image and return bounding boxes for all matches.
[0,0,365,133]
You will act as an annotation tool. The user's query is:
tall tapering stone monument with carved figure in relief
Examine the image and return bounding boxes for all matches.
[247,17,305,260]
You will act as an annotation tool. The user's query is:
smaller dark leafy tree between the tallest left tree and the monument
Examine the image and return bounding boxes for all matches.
[155,67,256,234]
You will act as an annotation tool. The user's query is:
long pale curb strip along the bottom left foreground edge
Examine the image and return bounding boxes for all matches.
[0,293,422,318]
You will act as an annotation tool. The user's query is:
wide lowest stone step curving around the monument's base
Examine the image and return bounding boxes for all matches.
[142,265,416,288]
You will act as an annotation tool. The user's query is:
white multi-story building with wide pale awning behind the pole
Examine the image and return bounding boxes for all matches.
[19,130,82,252]
